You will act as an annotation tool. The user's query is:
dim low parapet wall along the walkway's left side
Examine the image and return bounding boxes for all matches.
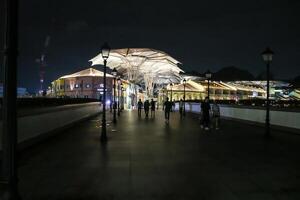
[0,102,102,149]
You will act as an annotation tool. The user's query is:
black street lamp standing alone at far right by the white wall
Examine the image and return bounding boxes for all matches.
[261,48,274,137]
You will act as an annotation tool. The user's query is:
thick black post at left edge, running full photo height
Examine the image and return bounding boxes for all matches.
[0,0,20,200]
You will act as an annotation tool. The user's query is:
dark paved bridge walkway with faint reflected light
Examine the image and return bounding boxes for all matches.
[19,111,300,200]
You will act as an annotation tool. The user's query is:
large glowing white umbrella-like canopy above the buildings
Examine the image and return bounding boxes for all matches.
[90,48,183,96]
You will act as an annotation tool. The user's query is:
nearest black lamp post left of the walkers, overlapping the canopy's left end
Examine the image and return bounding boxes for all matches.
[100,43,110,142]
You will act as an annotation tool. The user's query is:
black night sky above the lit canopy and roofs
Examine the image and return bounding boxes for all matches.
[0,0,300,91]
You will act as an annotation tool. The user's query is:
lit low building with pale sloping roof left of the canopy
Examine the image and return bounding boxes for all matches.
[47,68,130,109]
